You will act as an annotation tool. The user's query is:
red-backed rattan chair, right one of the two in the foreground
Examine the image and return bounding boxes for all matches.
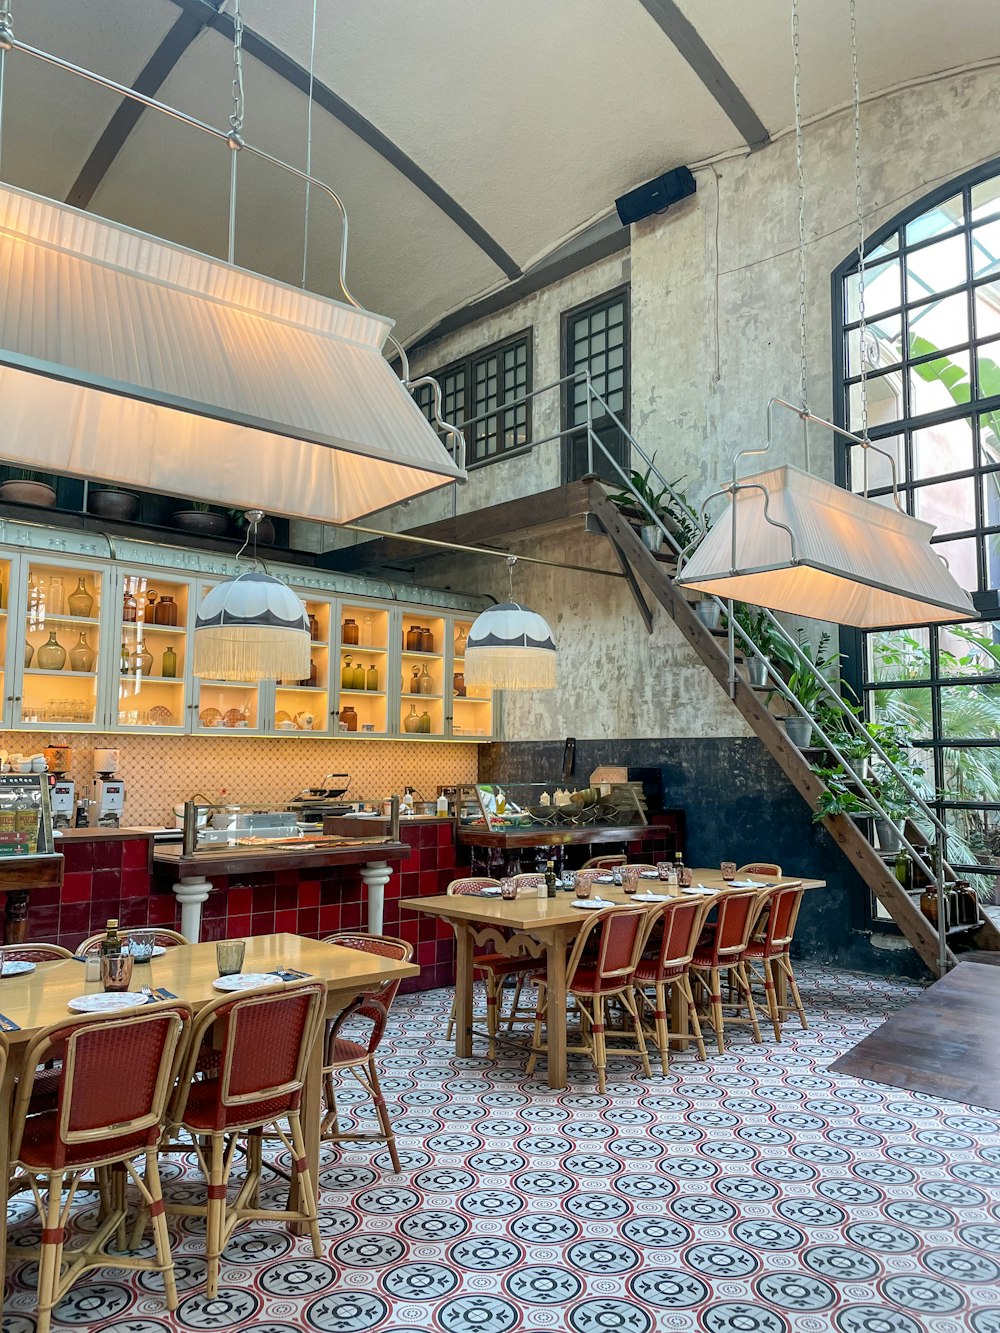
[154,981,327,1300]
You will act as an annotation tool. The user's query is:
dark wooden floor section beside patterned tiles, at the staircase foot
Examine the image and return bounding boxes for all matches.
[831,962,1000,1110]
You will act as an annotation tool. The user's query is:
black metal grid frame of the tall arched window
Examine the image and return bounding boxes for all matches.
[831,157,1000,929]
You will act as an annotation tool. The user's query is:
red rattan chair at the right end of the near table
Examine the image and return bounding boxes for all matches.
[321,930,413,1174]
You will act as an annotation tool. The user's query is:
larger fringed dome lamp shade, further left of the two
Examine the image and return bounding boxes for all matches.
[195,569,311,681]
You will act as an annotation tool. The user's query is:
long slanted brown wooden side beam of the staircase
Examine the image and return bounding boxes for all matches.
[588,479,1000,973]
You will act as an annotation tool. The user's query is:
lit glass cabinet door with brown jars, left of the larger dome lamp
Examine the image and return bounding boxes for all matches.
[115,571,191,730]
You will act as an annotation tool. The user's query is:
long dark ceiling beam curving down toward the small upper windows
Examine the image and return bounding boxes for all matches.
[165,0,521,279]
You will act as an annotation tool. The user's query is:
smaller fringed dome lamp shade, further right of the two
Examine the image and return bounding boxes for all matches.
[465,601,556,689]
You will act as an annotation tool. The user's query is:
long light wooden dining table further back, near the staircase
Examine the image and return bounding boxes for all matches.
[400,869,827,1088]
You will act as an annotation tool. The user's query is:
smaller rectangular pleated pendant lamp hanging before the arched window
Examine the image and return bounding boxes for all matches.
[677,467,976,629]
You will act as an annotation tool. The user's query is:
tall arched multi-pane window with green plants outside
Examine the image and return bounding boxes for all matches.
[833,160,1000,900]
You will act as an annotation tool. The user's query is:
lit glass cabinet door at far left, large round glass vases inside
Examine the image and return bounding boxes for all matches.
[19,557,108,729]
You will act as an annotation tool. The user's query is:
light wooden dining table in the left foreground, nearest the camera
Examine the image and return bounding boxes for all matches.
[0,934,420,1295]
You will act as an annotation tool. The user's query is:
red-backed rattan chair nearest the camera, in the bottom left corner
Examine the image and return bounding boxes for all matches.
[11,1000,191,1333]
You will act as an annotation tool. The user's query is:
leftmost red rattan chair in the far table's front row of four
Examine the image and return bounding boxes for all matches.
[527,908,651,1092]
